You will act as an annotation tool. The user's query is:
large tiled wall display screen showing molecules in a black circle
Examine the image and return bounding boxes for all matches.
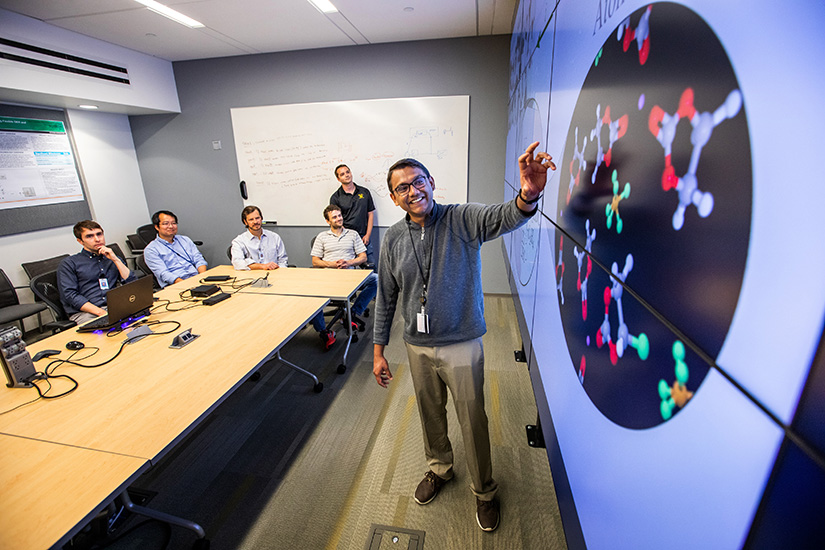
[504,0,825,549]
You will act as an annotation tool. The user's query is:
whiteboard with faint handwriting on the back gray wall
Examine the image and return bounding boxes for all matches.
[231,95,470,226]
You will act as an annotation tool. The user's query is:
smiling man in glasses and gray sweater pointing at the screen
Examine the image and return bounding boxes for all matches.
[373,142,556,531]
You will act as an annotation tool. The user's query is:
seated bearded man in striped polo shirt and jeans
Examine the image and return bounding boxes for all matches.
[310,204,378,328]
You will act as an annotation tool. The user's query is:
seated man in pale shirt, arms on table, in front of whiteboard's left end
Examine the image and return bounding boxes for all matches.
[232,205,287,271]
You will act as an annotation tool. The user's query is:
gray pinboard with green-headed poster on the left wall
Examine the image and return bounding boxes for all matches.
[0,104,91,235]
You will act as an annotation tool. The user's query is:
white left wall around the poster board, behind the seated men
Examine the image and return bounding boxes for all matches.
[0,111,150,328]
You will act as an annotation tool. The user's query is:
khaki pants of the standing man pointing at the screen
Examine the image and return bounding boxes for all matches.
[407,338,498,500]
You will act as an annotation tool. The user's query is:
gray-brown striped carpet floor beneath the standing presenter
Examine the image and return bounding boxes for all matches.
[112,296,567,550]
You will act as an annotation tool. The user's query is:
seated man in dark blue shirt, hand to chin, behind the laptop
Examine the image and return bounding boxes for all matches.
[57,220,135,325]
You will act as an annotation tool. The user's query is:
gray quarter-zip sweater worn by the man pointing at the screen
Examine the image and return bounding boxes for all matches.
[373,200,537,346]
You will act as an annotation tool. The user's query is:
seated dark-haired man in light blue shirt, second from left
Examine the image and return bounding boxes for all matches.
[143,210,207,288]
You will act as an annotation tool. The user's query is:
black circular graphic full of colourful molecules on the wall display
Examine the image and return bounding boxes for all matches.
[555,2,752,429]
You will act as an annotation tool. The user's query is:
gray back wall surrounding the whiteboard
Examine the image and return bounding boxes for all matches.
[130,36,510,293]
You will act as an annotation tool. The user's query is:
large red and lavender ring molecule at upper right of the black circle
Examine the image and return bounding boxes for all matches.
[648,88,742,231]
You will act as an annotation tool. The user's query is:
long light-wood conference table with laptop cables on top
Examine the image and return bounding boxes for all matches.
[0,285,328,548]
